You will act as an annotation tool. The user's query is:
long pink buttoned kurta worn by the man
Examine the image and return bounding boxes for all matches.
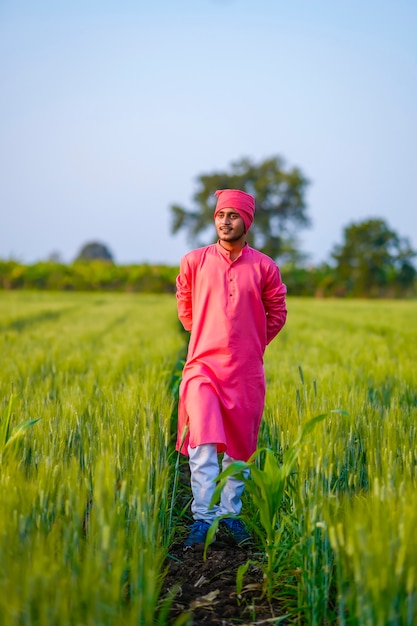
[177,243,287,461]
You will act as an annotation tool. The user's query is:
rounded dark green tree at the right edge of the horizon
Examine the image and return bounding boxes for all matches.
[331,219,416,296]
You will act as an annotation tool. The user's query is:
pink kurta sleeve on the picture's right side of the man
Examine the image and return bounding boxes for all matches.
[262,264,287,344]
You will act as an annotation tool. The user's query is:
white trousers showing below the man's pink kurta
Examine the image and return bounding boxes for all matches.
[188,443,249,523]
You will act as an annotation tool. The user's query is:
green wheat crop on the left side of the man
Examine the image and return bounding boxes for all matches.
[0,292,182,626]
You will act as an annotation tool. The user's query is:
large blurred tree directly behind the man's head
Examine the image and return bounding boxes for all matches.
[170,156,310,261]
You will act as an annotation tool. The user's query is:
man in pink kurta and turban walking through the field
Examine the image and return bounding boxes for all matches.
[177,189,287,548]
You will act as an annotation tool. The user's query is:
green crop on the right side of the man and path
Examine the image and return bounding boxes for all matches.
[260,299,417,626]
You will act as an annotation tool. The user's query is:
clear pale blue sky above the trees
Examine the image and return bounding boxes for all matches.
[0,0,417,264]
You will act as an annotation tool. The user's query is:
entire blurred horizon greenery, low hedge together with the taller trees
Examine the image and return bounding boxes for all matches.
[0,157,417,298]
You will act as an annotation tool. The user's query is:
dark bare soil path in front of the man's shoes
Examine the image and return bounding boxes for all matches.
[163,532,288,626]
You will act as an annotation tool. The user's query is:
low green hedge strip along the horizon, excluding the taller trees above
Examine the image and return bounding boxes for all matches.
[0,251,417,298]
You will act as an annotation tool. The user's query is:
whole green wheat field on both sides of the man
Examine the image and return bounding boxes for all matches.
[0,292,417,626]
